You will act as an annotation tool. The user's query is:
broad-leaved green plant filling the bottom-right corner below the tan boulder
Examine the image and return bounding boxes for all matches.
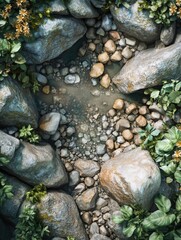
[113,195,181,240]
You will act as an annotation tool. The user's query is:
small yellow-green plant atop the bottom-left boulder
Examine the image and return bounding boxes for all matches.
[26,184,47,204]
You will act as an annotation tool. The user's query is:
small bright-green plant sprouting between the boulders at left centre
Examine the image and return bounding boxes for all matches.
[19,125,40,143]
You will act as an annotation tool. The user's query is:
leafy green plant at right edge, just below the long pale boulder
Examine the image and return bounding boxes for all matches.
[144,80,181,118]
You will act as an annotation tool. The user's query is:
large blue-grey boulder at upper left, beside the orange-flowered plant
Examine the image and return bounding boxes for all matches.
[23,17,86,64]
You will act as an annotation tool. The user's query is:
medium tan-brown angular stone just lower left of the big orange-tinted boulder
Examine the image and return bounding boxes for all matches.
[76,187,98,211]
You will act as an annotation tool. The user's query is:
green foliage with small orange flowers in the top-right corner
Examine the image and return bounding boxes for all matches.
[139,0,181,26]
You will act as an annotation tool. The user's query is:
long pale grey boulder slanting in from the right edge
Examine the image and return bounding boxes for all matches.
[113,43,181,93]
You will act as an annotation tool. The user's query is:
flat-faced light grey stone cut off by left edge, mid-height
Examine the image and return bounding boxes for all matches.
[0,130,20,160]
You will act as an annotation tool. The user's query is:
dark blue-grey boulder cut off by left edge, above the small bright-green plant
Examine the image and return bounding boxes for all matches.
[0,78,38,128]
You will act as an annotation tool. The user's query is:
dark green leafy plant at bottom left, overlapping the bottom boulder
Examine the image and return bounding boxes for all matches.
[15,205,49,240]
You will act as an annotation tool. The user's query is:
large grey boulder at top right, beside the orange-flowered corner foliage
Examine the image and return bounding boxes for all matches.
[110,1,160,43]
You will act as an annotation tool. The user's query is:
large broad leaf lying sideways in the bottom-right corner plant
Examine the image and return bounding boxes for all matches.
[142,210,176,230]
